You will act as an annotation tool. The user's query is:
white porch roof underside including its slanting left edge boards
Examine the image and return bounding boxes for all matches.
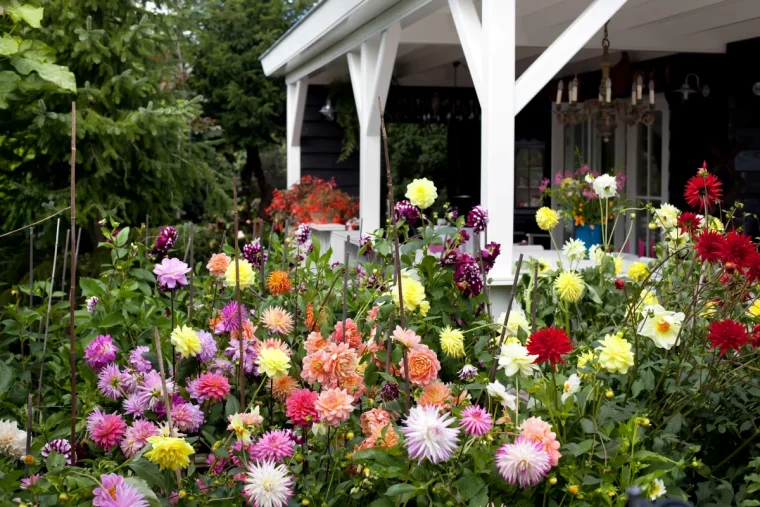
[262,0,760,86]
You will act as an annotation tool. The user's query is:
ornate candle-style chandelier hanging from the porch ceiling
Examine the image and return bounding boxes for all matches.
[554,24,655,142]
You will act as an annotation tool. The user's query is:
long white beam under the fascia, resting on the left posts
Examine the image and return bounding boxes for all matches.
[284,0,434,83]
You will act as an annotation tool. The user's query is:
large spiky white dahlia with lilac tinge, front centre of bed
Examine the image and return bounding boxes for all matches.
[401,406,459,464]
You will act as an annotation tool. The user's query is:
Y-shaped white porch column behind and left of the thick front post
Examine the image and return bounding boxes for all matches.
[347,23,401,231]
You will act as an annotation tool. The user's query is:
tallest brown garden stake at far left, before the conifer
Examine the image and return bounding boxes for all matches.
[69,102,77,465]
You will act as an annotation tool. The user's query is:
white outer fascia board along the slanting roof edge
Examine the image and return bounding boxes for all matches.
[261,0,367,76]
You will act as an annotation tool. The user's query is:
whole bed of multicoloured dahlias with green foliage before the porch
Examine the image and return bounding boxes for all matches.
[0,168,760,507]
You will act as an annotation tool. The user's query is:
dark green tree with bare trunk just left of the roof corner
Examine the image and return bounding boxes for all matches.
[189,0,314,219]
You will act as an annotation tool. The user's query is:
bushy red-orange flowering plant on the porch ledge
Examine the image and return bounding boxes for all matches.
[266,175,359,230]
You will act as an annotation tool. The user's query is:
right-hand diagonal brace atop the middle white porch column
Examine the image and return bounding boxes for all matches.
[362,23,401,135]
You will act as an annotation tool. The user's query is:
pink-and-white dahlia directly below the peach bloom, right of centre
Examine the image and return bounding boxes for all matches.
[496,435,551,488]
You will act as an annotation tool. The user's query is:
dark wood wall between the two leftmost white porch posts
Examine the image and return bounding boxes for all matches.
[301,85,359,197]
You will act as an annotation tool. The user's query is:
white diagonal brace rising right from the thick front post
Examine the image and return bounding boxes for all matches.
[516,0,628,113]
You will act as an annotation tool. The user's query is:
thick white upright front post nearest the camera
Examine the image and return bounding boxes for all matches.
[479,0,516,284]
